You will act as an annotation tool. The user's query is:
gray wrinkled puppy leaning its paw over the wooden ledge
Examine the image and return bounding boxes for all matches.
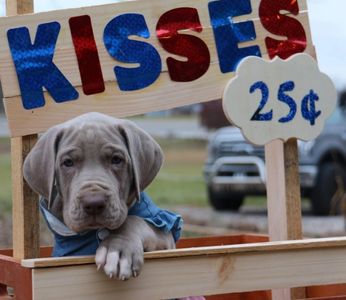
[23,113,175,280]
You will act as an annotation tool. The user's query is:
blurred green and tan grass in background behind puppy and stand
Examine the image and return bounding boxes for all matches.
[0,138,266,214]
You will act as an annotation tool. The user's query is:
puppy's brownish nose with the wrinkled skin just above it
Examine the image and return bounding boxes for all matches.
[78,184,110,216]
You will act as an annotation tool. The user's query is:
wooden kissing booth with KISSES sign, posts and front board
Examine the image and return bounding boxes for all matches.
[0,0,346,300]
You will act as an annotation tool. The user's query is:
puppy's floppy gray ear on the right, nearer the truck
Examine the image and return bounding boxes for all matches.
[119,121,163,200]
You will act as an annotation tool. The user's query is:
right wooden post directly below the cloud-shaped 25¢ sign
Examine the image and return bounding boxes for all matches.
[265,139,305,300]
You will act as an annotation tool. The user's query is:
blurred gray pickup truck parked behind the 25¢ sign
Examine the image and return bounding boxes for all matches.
[204,106,346,215]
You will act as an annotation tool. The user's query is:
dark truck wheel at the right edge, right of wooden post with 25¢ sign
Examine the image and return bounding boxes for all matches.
[311,162,346,216]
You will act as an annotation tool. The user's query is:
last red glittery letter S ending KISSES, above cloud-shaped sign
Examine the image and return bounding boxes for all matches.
[259,0,307,59]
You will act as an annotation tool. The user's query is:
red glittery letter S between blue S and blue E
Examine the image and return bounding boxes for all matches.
[156,7,210,82]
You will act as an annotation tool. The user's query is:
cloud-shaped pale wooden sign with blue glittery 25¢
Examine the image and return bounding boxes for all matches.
[223,54,337,145]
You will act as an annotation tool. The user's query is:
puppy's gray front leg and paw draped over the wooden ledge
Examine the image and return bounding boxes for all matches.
[95,216,175,280]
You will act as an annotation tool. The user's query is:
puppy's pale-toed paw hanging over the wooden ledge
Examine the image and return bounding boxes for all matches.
[95,234,144,280]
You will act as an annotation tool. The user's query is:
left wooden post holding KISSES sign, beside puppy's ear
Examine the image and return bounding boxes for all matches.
[6,0,40,259]
